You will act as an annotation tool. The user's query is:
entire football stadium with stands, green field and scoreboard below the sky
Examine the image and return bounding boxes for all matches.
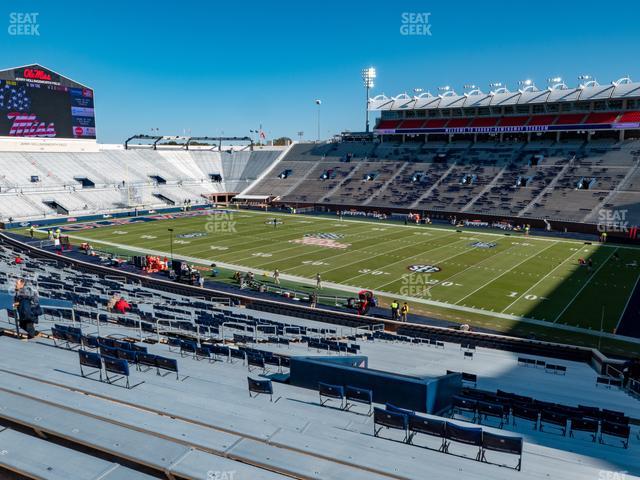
[0,4,640,480]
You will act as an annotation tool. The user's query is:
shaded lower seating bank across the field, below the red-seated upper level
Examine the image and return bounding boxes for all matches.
[241,139,640,222]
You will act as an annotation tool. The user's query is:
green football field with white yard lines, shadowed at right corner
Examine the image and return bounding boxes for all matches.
[51,210,640,338]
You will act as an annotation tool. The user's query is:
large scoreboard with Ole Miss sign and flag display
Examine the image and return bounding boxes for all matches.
[0,64,96,139]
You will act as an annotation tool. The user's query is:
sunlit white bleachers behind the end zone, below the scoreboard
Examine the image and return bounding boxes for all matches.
[0,146,282,221]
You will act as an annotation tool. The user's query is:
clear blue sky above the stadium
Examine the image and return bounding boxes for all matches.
[0,0,640,143]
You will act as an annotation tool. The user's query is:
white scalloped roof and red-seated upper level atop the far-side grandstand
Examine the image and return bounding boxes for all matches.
[369,77,640,141]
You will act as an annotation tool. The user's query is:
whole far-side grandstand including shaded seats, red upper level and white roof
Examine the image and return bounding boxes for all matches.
[241,79,640,236]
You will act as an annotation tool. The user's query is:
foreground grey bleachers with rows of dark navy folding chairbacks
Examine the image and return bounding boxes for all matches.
[0,234,640,480]
